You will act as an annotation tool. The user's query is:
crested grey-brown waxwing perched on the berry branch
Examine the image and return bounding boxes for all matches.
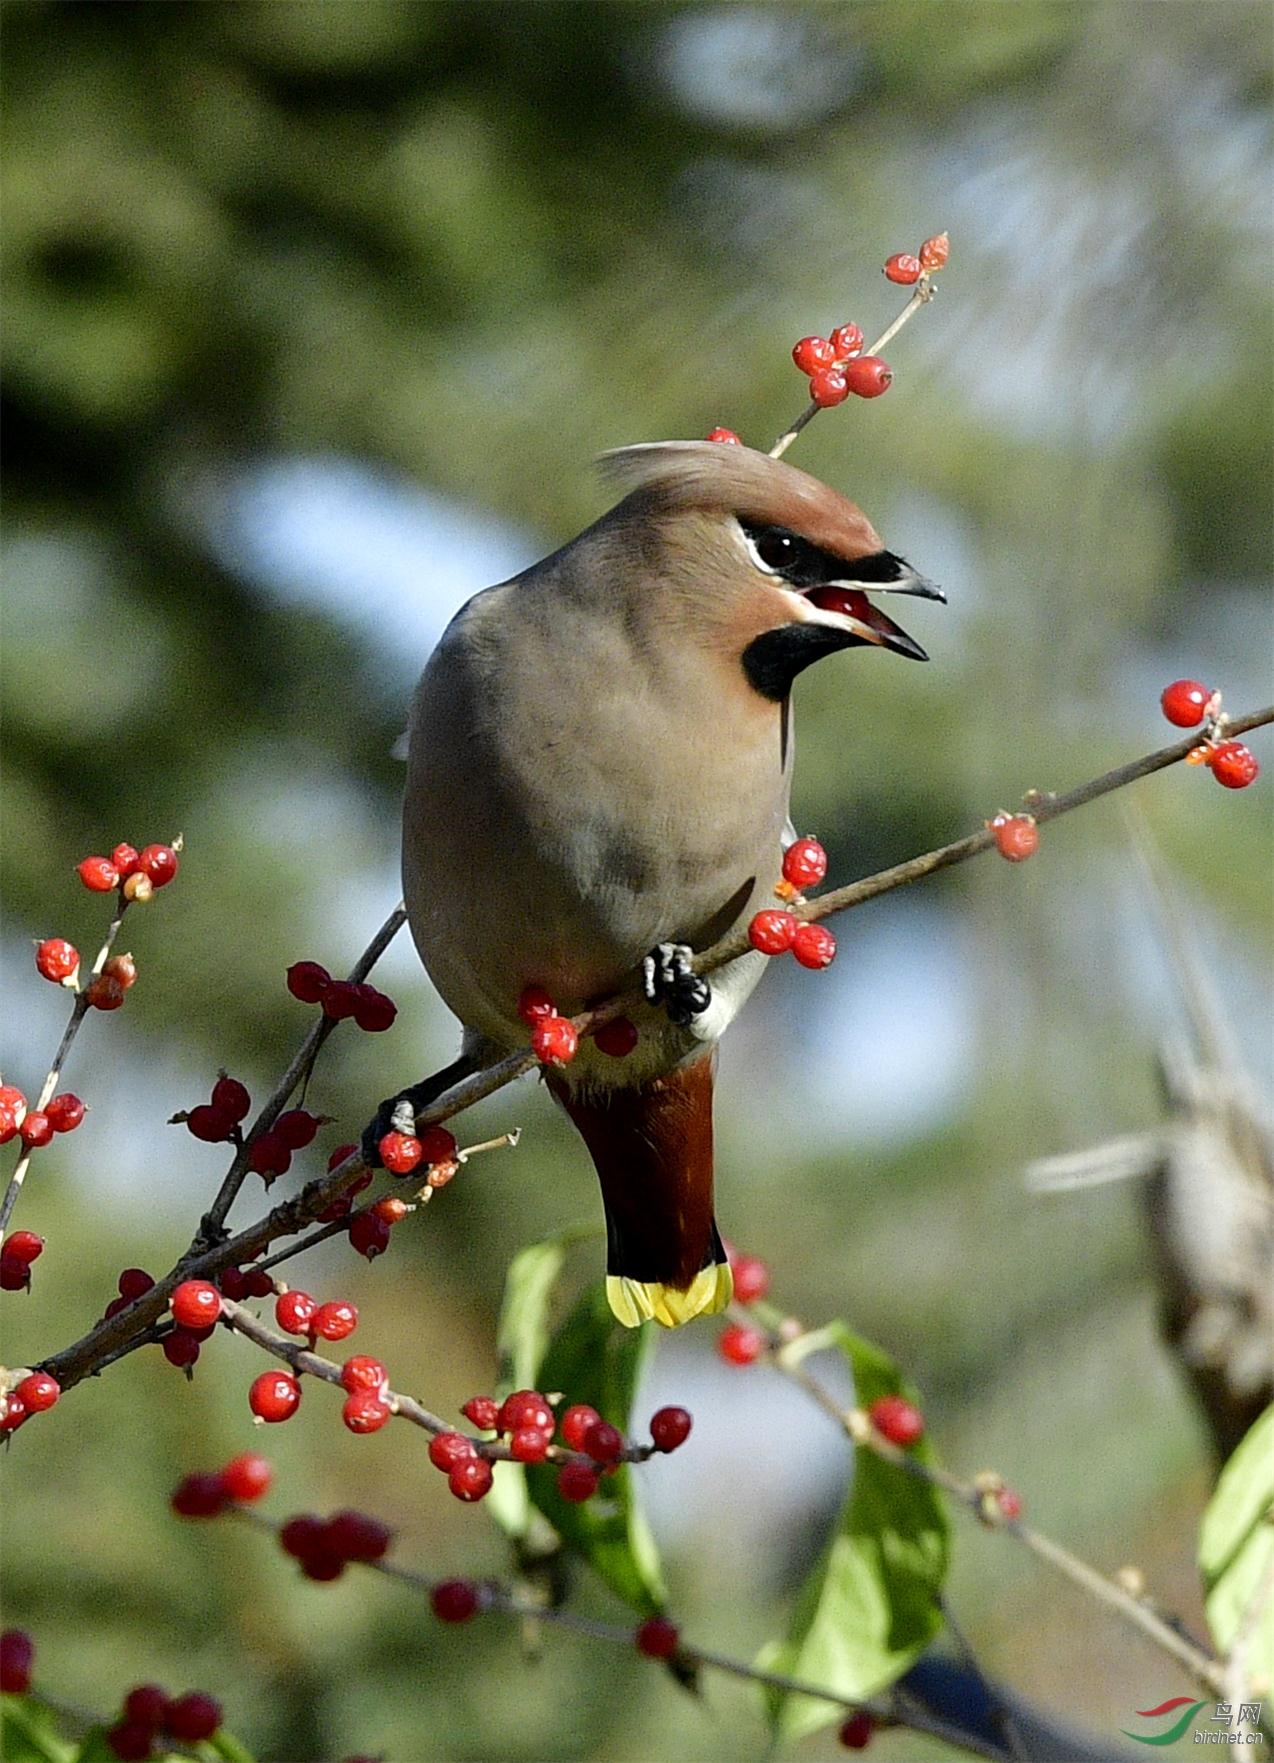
[363,441,944,1328]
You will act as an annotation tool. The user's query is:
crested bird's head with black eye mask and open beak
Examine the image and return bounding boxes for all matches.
[603,441,946,700]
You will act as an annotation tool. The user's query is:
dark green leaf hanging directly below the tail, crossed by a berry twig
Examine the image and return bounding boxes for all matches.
[525,1285,668,1617]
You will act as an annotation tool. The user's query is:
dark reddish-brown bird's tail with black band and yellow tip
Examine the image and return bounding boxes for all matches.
[548,1053,733,1328]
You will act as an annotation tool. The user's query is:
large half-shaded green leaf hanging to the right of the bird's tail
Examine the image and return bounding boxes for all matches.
[758,1322,948,1740]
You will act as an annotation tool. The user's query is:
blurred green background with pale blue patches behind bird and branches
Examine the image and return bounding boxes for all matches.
[0,0,1272,1763]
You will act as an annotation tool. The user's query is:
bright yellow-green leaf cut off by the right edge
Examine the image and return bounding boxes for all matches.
[1198,1407,1274,1663]
